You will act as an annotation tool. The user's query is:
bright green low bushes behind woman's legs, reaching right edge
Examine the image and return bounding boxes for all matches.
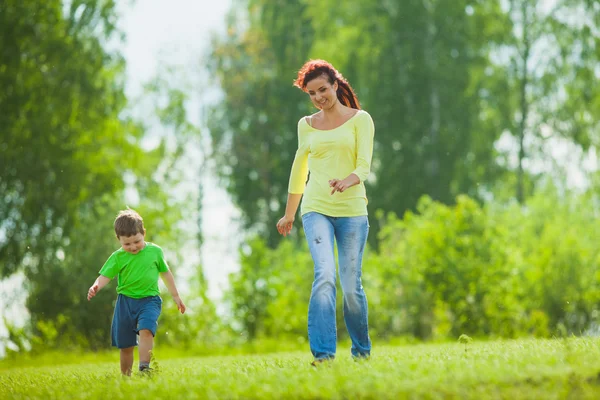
[227,187,600,340]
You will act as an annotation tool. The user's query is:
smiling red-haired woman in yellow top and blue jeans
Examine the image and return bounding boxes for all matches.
[277,60,375,365]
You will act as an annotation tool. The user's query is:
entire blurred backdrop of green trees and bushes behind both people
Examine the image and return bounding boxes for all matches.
[0,0,600,360]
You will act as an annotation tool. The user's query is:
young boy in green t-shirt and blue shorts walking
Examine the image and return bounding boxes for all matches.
[88,209,185,376]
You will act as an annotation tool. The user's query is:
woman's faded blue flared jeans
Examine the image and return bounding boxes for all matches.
[302,212,371,359]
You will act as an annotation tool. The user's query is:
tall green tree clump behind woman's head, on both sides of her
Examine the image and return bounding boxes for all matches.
[208,0,510,247]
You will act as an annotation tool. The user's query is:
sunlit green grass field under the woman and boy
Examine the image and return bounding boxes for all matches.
[0,338,600,400]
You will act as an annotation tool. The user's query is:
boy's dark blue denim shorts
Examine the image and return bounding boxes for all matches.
[111,294,162,349]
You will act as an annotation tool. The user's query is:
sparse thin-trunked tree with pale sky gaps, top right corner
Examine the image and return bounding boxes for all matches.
[503,0,600,203]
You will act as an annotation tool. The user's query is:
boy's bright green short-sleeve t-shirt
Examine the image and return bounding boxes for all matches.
[100,242,169,299]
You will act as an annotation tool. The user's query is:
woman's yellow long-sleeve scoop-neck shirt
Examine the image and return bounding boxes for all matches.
[288,110,375,217]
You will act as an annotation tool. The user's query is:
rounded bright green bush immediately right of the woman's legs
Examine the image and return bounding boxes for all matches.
[374,196,521,338]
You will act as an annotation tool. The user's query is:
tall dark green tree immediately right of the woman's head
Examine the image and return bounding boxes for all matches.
[314,1,508,227]
